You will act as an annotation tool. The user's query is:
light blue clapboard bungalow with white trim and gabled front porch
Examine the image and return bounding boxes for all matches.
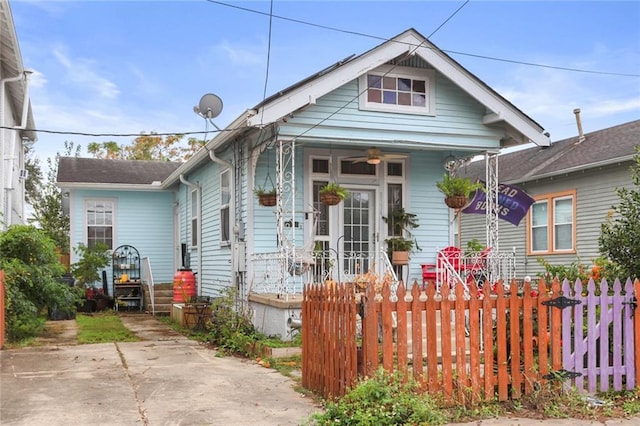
[58,29,549,336]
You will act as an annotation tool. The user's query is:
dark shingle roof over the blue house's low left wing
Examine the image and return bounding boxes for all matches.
[57,157,182,185]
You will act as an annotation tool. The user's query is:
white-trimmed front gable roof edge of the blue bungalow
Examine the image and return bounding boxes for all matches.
[247,29,550,146]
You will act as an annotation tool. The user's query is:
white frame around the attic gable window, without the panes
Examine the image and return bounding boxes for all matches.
[358,65,436,116]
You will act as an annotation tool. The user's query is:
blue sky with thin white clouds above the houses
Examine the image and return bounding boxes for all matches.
[9,0,640,165]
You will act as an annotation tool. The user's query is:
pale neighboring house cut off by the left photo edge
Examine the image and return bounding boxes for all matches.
[0,0,36,231]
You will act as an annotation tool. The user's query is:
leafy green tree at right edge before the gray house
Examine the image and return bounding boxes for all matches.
[598,147,640,279]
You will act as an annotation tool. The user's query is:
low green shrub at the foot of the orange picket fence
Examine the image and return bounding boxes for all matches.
[312,369,446,425]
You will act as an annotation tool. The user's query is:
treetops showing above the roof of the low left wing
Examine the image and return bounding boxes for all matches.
[87,132,204,161]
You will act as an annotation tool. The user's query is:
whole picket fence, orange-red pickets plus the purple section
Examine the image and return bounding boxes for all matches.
[302,280,640,403]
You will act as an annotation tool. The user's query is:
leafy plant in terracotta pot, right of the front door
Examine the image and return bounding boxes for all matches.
[382,208,420,265]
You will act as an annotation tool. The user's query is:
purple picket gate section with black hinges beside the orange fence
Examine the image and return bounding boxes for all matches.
[562,279,640,392]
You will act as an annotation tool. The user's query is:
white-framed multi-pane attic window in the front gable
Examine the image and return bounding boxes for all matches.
[358,66,436,115]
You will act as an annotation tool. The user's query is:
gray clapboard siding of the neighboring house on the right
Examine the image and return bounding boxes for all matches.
[461,162,632,276]
